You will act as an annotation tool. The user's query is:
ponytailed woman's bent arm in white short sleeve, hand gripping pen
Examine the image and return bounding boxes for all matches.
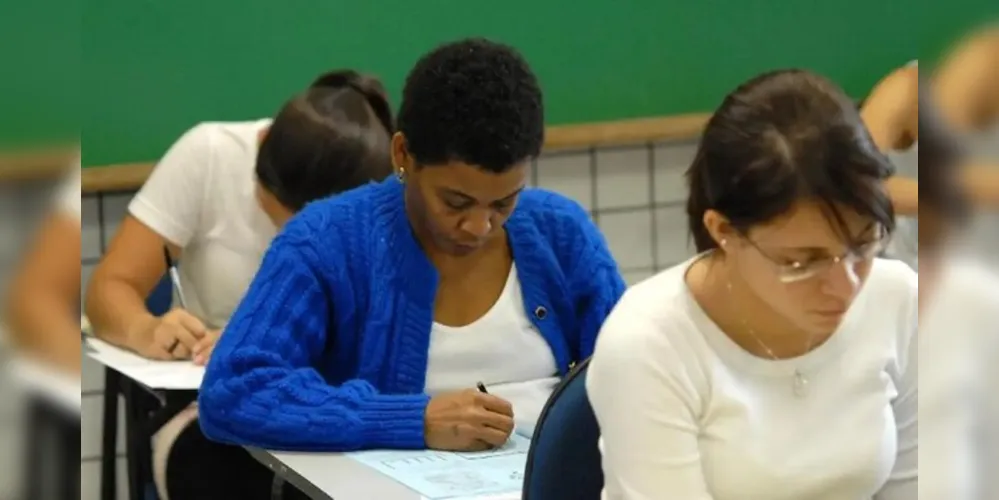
[86,125,212,359]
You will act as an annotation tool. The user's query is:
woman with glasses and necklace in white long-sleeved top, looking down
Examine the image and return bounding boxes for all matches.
[586,70,918,500]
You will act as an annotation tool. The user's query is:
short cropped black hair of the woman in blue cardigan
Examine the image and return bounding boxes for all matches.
[398,38,544,173]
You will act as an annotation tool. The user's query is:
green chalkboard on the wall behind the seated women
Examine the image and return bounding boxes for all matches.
[82,0,994,166]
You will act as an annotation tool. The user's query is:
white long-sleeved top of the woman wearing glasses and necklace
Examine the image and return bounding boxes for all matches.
[586,259,918,500]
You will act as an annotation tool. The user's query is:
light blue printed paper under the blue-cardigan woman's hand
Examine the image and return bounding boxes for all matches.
[347,434,531,500]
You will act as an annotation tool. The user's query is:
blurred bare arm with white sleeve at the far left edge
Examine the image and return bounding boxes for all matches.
[4,162,82,376]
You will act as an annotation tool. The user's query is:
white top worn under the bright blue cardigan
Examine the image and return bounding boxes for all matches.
[426,265,559,437]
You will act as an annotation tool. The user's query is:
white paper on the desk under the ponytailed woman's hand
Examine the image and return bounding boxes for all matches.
[86,337,205,390]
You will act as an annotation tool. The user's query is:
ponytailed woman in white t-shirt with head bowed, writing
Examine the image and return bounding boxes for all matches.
[86,71,394,500]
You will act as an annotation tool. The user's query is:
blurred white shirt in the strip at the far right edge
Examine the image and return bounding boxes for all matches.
[919,257,999,500]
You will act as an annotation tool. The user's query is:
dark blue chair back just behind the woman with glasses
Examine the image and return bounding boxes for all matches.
[522,359,604,500]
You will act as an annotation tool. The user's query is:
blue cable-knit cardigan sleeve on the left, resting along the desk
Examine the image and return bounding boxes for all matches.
[198,225,428,451]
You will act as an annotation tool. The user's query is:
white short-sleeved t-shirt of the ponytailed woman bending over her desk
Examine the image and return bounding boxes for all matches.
[128,120,277,328]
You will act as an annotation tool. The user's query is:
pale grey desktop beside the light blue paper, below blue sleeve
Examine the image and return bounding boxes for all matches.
[246,447,422,500]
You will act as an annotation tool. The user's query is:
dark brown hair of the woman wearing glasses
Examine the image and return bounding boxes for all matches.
[687,69,895,252]
